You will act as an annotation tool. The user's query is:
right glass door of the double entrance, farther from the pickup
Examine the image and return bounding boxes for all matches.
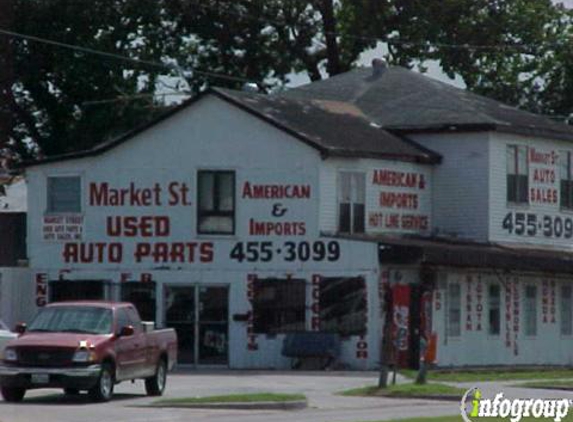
[198,286,229,365]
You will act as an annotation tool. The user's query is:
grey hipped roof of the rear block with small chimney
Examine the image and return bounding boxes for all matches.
[279,67,573,140]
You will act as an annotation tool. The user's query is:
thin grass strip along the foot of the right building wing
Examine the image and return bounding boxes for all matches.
[400,368,573,382]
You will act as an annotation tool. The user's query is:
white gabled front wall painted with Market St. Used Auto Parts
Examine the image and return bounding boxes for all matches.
[27,97,380,369]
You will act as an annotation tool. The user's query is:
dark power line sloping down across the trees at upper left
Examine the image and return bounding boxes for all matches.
[0,29,254,83]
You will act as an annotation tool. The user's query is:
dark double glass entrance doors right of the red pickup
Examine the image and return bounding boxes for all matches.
[164,284,229,365]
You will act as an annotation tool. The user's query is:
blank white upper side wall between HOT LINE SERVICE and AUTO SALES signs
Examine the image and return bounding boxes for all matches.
[411,132,490,241]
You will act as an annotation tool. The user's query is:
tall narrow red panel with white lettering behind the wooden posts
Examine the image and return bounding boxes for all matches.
[392,285,411,367]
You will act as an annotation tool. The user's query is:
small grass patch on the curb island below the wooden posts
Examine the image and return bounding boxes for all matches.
[340,383,465,399]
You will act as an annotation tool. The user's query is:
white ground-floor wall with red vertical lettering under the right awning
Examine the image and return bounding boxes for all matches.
[433,271,573,367]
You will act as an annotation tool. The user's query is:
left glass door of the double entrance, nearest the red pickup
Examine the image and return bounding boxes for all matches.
[164,285,197,364]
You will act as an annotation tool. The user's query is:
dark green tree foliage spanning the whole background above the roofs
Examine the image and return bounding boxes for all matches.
[0,0,573,162]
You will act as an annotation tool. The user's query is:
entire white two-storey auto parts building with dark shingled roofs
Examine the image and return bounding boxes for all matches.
[26,63,573,369]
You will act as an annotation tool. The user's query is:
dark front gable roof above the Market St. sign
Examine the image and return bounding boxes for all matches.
[23,88,441,166]
